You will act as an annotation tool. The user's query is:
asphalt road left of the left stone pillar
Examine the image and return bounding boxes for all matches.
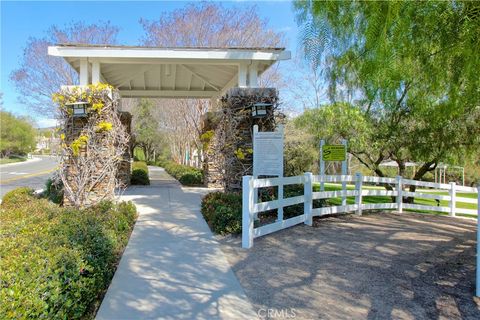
[0,156,58,197]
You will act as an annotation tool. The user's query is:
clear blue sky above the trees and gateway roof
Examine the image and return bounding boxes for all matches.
[0,0,298,126]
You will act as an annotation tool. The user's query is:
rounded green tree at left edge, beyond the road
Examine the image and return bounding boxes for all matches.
[0,111,36,157]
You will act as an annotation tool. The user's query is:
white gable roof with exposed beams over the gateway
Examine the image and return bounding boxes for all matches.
[48,44,291,98]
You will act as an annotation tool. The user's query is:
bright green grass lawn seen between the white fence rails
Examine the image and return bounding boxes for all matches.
[318,183,477,215]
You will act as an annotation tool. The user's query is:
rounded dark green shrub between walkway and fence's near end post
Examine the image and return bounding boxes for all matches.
[201,192,242,234]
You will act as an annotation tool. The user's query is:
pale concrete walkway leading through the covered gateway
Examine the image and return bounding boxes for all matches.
[96,167,257,320]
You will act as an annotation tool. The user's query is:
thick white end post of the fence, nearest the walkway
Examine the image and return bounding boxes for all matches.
[242,176,255,249]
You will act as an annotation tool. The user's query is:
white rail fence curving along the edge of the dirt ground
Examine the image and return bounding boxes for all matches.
[242,172,480,248]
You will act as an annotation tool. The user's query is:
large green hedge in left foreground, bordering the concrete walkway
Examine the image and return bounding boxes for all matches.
[0,188,136,319]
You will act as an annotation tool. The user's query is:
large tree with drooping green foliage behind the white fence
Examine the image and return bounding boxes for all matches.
[295,1,480,179]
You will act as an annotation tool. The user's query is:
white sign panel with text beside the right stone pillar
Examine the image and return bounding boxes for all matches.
[253,126,283,177]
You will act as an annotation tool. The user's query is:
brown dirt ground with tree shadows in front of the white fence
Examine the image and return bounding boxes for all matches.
[220,213,480,319]
